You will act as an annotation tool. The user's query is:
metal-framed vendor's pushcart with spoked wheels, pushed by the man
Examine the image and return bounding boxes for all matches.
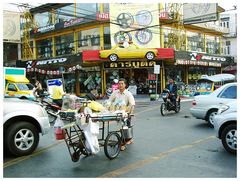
[60,111,133,162]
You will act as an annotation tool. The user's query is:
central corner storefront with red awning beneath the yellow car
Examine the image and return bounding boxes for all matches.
[82,48,174,95]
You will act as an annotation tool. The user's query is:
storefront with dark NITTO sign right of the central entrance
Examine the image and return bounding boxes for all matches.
[173,51,233,96]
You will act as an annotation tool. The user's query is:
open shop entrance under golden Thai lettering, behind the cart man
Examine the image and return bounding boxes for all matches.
[104,60,161,95]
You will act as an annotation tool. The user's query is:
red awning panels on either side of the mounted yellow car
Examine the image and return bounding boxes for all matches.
[82,48,174,61]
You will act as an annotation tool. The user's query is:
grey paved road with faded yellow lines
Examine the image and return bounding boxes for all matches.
[3,101,237,178]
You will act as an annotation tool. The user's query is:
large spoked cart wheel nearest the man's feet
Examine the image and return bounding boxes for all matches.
[104,132,121,160]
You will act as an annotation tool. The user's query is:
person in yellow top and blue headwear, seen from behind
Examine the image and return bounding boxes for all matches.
[52,80,66,107]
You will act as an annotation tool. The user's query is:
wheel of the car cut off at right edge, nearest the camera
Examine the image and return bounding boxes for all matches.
[221,124,237,154]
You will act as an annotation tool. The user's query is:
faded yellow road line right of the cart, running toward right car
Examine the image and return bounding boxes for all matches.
[97,136,216,178]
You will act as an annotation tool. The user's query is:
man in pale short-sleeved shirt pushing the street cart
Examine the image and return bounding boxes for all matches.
[109,78,135,151]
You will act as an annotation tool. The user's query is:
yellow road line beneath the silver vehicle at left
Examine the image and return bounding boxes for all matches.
[3,141,64,168]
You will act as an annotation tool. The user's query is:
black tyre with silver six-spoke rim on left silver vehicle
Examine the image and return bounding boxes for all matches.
[5,122,39,156]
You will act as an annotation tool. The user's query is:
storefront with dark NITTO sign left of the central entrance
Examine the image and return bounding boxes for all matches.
[25,53,83,92]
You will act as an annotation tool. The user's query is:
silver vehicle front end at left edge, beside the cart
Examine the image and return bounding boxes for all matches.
[3,98,50,156]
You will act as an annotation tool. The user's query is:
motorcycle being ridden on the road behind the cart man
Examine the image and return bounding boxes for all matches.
[160,89,181,116]
